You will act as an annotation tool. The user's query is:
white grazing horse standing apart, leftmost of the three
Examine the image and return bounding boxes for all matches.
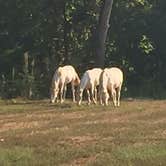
[51,65,80,103]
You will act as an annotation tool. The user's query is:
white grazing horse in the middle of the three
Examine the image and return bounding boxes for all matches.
[78,68,102,105]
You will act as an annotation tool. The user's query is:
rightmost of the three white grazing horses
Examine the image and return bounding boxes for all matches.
[99,67,123,106]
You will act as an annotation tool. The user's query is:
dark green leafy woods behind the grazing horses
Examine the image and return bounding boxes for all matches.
[0,0,166,98]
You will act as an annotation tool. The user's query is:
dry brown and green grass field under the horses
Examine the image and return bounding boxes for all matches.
[0,100,166,166]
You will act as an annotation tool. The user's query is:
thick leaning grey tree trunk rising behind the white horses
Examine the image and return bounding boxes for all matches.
[95,0,113,67]
